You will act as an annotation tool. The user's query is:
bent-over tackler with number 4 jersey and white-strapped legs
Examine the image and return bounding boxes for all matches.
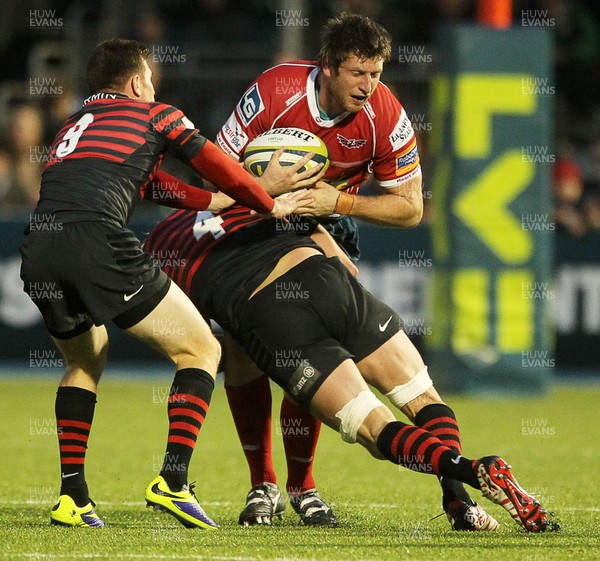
[145,205,558,532]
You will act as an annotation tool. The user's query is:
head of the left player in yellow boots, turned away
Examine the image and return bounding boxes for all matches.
[86,39,154,101]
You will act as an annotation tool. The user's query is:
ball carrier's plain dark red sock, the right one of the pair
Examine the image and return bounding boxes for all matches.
[279,397,321,495]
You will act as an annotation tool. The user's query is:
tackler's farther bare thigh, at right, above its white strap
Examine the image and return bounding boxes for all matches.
[357,331,425,393]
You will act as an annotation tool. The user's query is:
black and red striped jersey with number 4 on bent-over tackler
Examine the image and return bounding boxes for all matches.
[144,205,320,333]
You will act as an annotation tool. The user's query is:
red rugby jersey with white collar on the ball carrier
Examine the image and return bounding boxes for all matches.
[217,61,421,194]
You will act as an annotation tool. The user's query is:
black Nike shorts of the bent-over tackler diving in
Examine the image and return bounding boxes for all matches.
[234,255,402,406]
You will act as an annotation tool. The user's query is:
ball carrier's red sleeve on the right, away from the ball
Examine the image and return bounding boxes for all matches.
[373,84,421,189]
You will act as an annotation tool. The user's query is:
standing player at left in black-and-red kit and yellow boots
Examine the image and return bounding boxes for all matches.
[21,39,302,528]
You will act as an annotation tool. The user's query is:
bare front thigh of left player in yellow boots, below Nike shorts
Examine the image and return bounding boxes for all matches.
[127,283,221,375]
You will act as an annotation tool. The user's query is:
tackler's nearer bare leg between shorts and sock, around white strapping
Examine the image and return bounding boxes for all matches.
[309,359,396,453]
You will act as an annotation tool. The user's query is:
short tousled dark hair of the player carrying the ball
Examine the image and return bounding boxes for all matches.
[318,12,392,71]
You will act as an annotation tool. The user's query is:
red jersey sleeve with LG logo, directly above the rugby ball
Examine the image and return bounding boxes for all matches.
[216,71,273,160]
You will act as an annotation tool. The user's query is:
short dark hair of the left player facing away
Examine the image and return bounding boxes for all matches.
[86,39,150,94]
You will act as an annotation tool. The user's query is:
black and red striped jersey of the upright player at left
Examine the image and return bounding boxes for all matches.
[35,93,206,225]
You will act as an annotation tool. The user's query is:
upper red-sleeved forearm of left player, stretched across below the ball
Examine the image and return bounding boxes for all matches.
[190,141,275,214]
